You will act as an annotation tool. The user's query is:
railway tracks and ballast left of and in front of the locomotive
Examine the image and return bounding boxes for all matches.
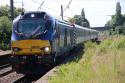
[0,53,51,83]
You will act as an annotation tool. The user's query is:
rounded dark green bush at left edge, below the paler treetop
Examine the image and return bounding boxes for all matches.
[0,16,11,49]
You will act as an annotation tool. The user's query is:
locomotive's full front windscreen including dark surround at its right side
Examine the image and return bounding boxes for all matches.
[17,19,52,37]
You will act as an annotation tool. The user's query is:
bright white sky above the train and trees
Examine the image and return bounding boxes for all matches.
[0,0,125,27]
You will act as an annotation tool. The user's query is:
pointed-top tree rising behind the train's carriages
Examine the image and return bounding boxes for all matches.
[69,9,90,27]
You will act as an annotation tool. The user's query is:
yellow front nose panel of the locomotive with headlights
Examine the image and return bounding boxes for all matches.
[12,40,51,55]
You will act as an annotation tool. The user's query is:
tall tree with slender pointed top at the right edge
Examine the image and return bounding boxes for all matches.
[105,2,125,35]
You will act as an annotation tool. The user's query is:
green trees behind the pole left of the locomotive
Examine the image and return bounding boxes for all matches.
[0,5,22,50]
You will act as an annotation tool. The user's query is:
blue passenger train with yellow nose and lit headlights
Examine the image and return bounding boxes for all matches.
[10,11,99,73]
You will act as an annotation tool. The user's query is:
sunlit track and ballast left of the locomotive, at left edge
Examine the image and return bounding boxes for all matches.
[0,51,24,83]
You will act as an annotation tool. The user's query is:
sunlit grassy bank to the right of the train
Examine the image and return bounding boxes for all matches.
[49,36,125,83]
